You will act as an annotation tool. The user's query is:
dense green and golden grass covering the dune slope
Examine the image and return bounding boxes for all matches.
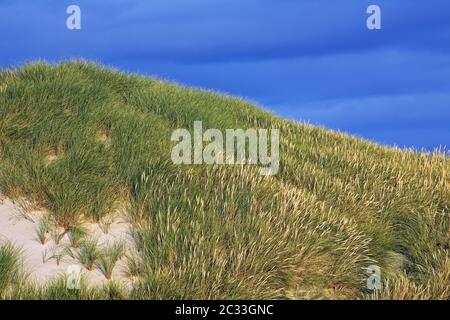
[0,62,450,299]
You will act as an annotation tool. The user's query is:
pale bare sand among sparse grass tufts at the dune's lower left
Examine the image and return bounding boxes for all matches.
[0,199,136,286]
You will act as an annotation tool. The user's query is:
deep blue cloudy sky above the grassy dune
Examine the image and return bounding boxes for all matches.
[0,0,450,149]
